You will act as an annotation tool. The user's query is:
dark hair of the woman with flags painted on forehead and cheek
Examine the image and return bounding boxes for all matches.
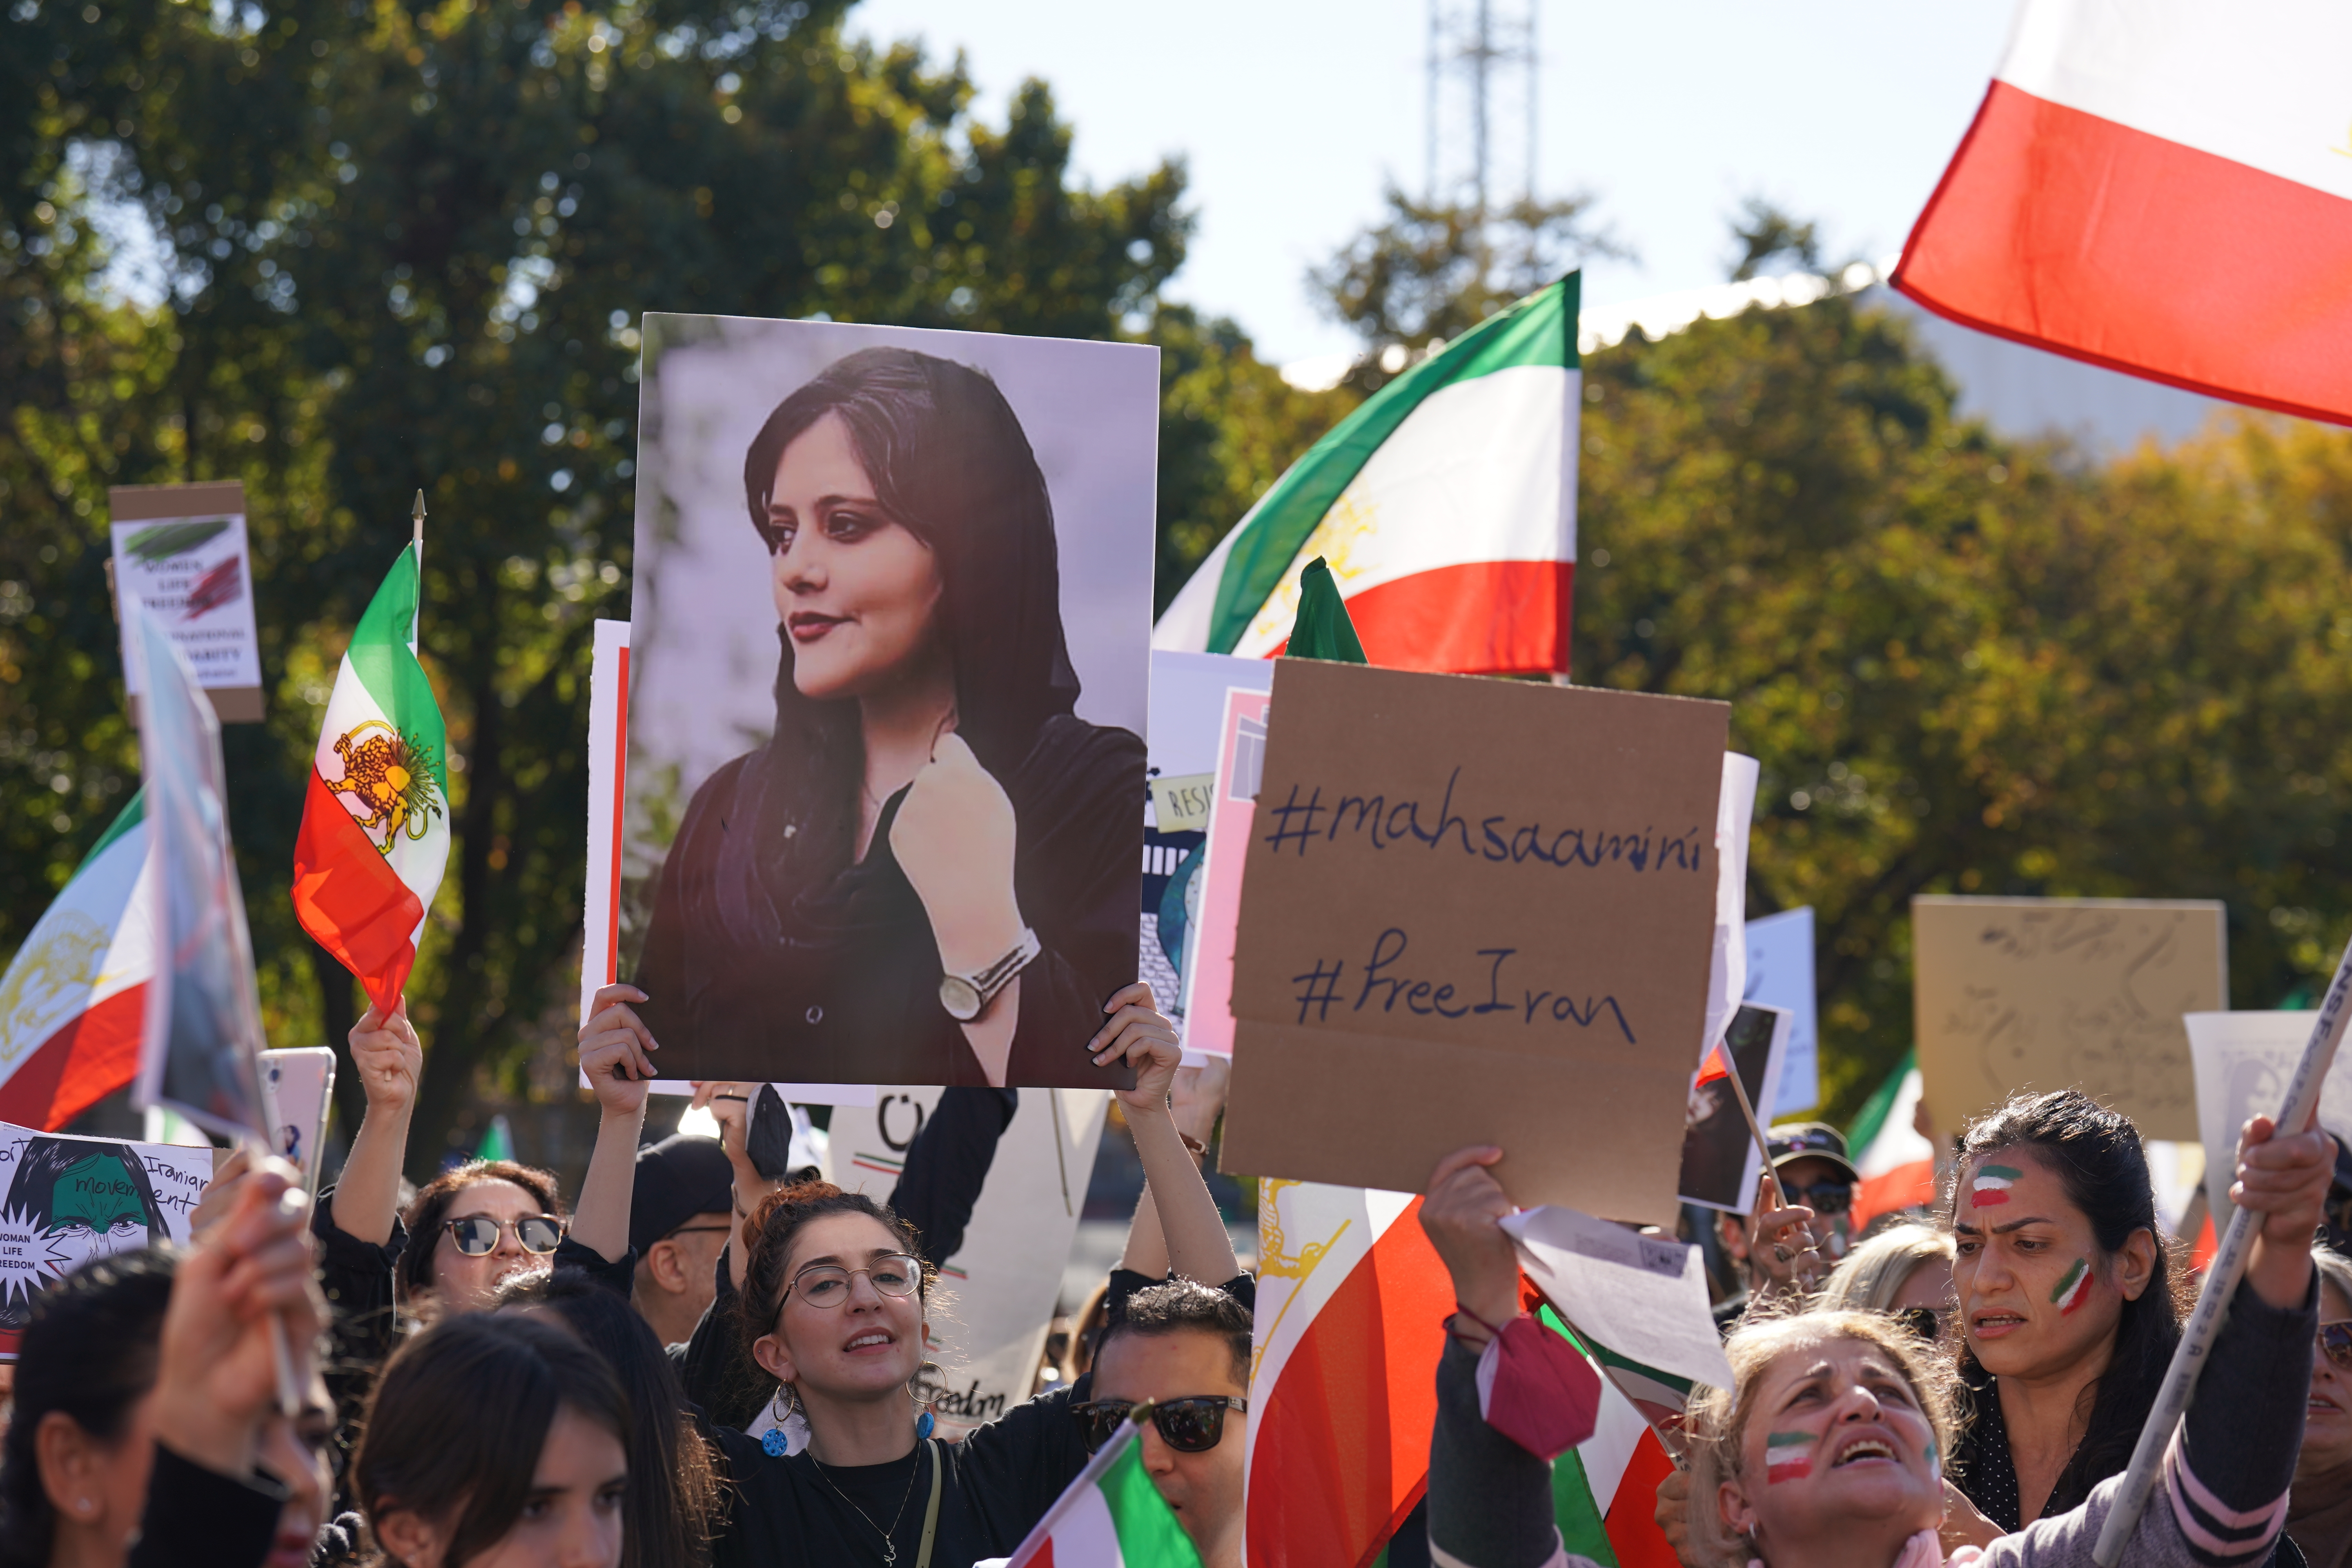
[1945,1089,2187,1500]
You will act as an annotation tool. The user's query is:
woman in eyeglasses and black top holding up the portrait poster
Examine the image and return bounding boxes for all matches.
[574,985,1242,1568]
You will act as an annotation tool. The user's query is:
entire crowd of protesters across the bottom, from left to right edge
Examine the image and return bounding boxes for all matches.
[23,968,2352,1568]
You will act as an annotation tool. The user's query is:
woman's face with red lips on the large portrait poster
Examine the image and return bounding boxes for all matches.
[767,414,941,701]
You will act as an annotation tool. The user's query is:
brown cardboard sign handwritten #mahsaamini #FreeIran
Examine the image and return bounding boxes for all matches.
[1223,658,1731,1225]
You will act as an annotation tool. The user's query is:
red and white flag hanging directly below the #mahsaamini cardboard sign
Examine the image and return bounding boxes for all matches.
[1244,1180,1454,1568]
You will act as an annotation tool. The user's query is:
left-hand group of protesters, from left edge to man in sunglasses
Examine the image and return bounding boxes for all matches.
[0,985,1254,1568]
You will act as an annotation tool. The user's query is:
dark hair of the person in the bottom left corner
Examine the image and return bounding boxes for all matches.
[0,1246,179,1568]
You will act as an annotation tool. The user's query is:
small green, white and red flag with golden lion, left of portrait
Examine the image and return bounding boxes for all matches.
[294,543,449,1011]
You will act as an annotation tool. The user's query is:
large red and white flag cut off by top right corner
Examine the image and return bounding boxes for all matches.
[1893,0,2352,423]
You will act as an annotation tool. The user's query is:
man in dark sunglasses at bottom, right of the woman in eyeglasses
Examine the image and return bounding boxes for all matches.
[1070,1279,1249,1568]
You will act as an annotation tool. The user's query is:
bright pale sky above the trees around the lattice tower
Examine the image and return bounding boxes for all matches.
[849,0,2011,362]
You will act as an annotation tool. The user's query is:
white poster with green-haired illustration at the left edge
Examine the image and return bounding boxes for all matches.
[0,1122,212,1361]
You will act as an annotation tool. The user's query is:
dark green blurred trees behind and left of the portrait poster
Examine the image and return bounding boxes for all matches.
[0,0,1279,1171]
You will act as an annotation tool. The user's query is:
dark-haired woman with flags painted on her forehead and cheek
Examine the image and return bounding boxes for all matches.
[1950,1089,2183,1535]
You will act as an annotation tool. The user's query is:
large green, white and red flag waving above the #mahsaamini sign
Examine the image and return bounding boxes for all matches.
[1152,273,1583,675]
